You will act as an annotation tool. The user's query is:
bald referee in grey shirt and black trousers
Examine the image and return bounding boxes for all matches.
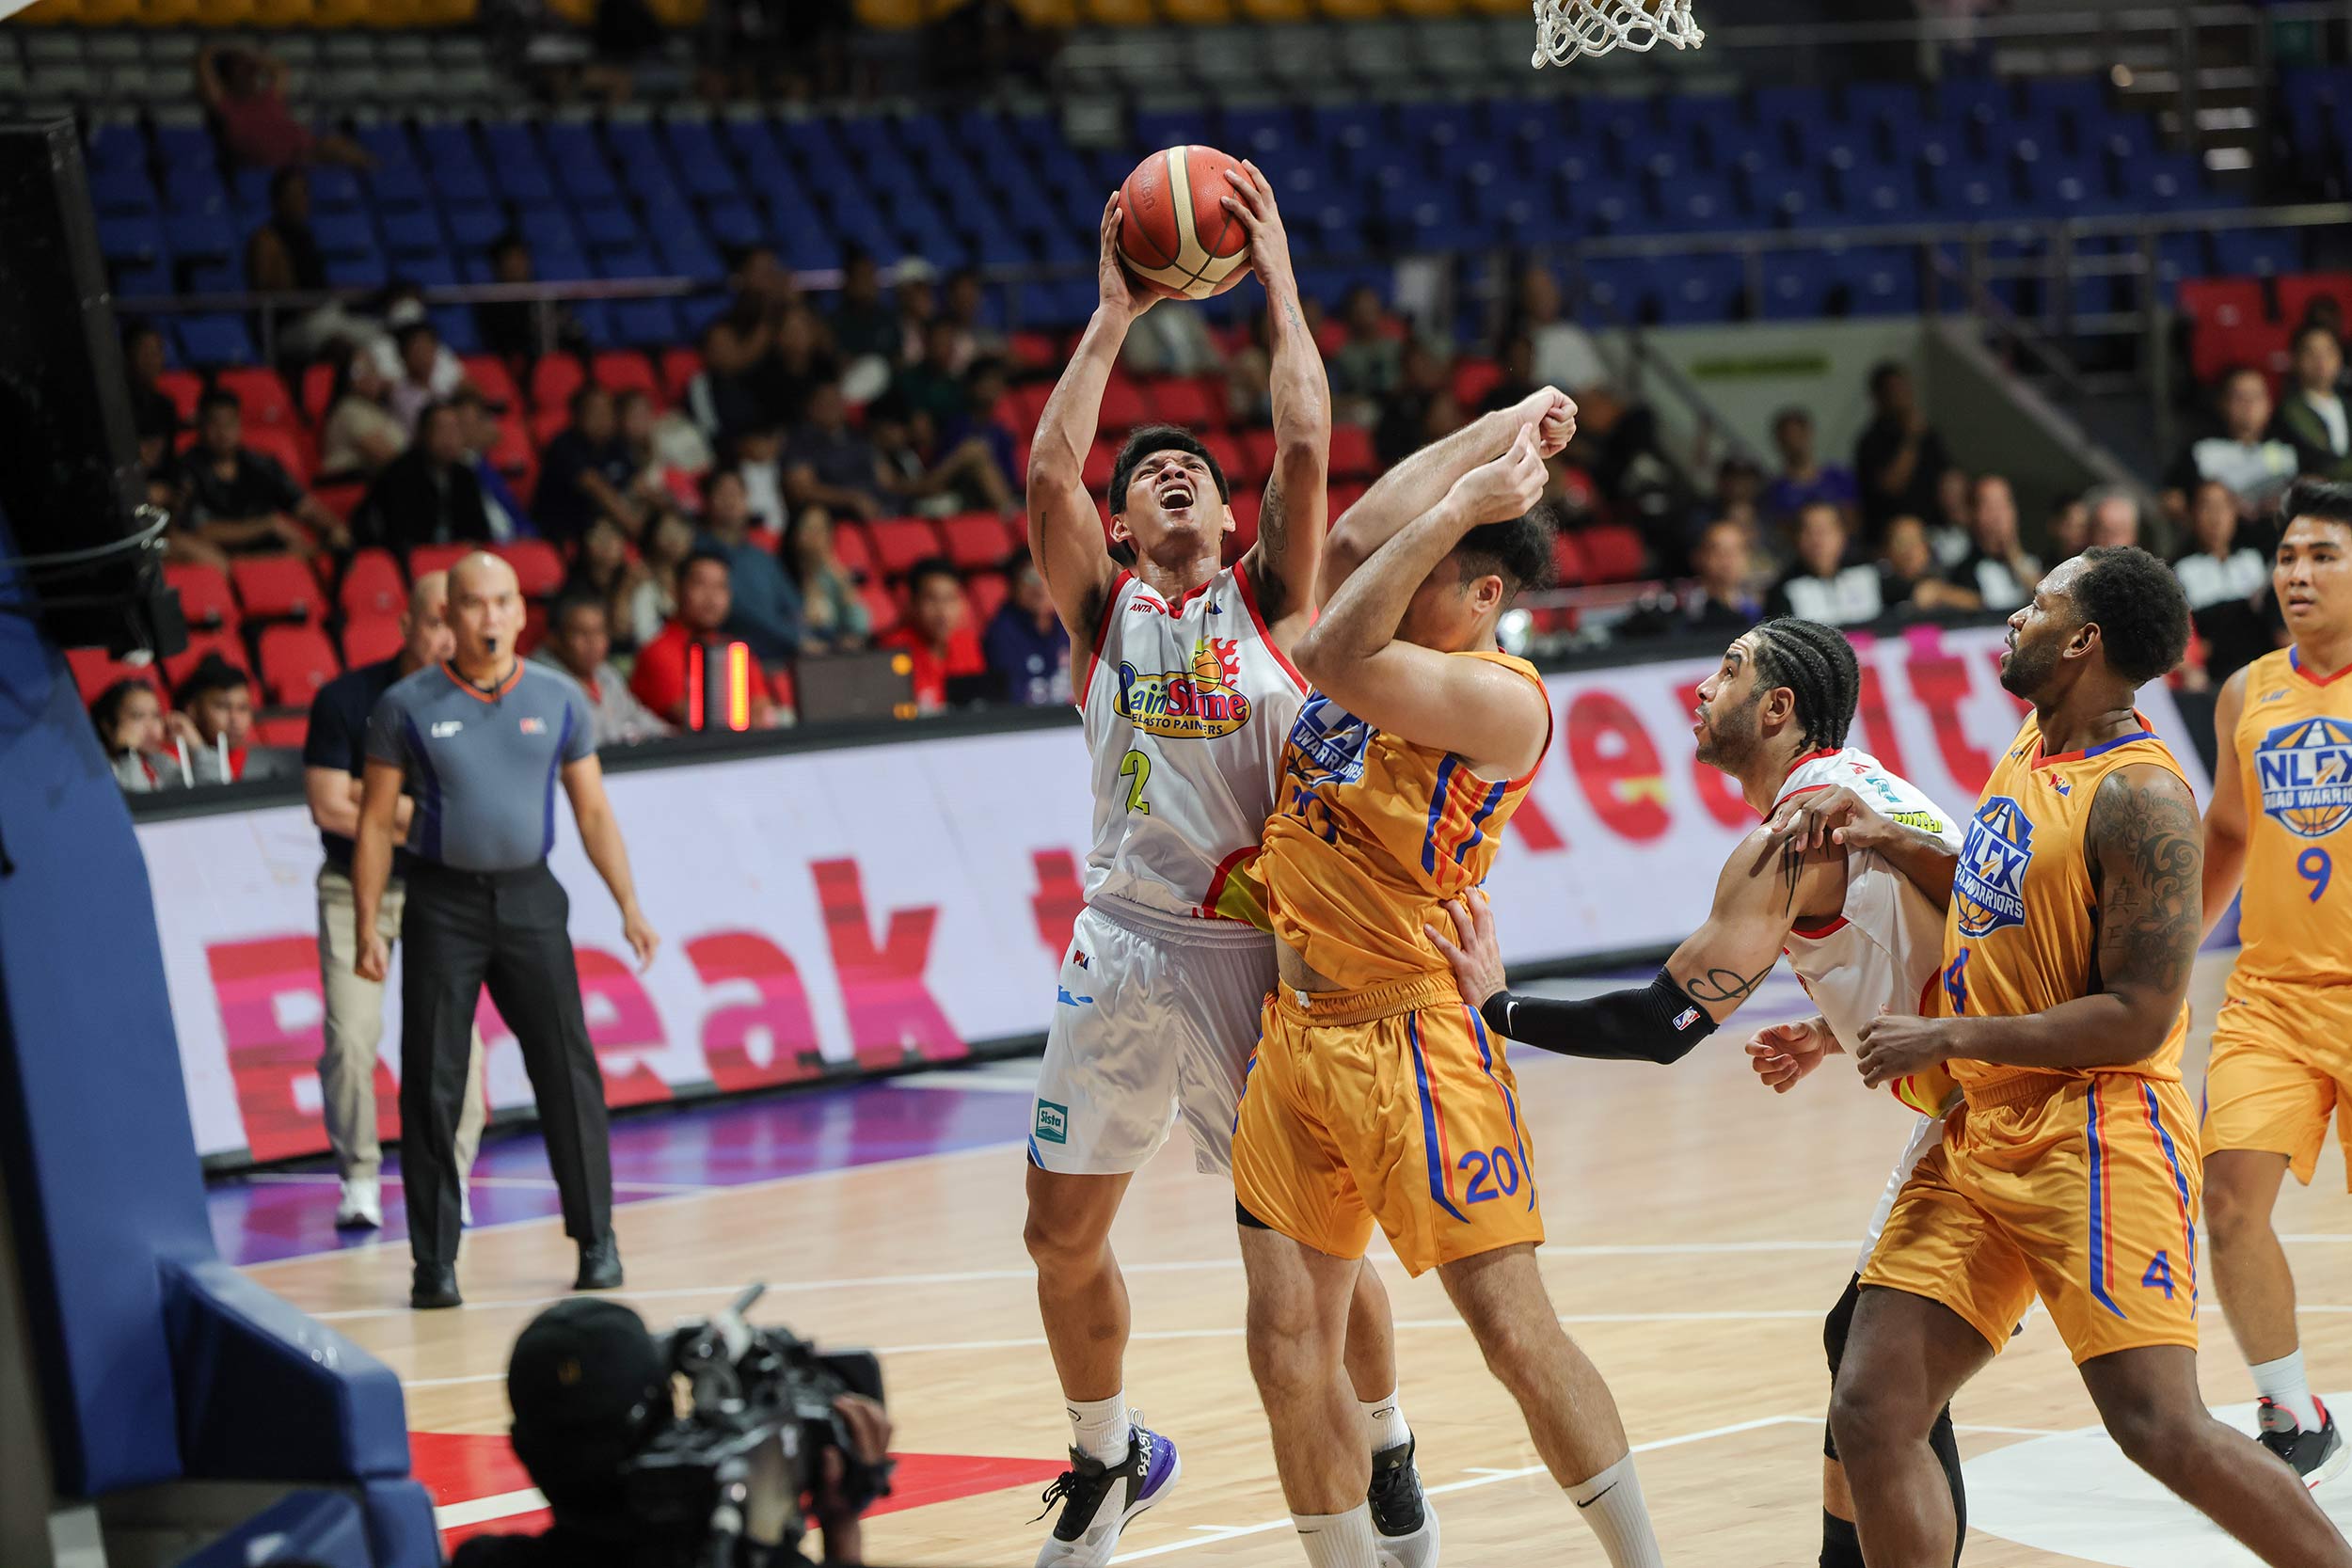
[351,552,661,1309]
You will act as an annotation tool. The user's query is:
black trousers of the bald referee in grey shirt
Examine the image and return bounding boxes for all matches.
[400,861,612,1265]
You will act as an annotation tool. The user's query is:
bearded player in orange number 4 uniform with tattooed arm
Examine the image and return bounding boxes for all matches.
[1830,547,2352,1568]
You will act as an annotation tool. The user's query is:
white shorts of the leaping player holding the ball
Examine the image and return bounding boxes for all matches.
[1028,903,1275,1176]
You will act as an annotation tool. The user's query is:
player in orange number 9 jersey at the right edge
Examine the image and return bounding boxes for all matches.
[2200,482,2352,1486]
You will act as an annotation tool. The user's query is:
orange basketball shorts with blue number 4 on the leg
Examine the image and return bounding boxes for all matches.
[1863,1072,2204,1366]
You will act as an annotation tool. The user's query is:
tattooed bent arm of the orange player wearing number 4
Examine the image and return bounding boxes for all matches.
[1856,764,2204,1086]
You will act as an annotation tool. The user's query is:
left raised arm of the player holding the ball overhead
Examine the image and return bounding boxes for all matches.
[1028,195,1152,663]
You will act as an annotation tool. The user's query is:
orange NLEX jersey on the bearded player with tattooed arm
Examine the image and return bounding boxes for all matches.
[1943,720,2187,1105]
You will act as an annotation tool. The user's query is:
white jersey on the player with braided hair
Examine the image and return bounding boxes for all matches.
[1773,745,1962,1081]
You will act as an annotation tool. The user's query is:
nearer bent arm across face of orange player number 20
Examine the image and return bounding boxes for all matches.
[1296,425,1550,778]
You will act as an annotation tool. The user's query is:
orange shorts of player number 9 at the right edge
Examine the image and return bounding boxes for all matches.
[2200,975,2352,1190]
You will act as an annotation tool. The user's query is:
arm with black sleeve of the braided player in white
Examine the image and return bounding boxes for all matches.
[1428,828,1847,1065]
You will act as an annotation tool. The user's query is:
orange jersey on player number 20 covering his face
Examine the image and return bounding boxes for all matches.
[1256,654,1550,990]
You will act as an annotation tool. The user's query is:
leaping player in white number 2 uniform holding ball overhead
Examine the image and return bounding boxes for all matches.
[1025,166,1438,1568]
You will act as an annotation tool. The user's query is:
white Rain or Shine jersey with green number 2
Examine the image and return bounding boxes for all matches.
[1077,566,1308,917]
